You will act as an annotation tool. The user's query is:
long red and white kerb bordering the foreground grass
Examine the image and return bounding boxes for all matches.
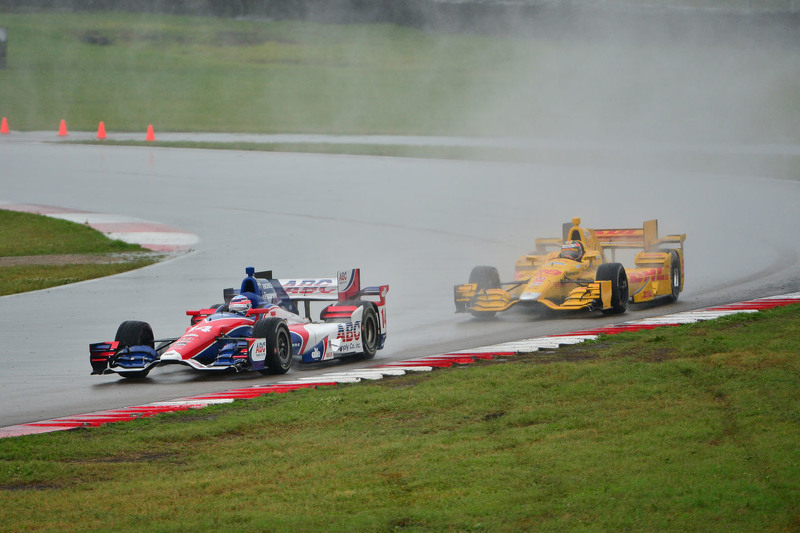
[0,292,800,438]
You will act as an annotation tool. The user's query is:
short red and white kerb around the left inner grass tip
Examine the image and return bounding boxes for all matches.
[0,203,200,252]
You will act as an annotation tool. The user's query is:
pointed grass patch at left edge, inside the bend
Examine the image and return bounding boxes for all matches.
[0,210,158,296]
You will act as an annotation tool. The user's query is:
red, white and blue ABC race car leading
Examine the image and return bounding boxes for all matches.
[89,267,389,378]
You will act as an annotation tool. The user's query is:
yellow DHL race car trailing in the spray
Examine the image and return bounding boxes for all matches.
[454,218,686,318]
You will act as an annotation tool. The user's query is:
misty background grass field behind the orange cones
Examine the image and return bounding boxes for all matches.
[0,13,800,148]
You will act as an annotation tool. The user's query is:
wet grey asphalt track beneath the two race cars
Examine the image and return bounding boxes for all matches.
[0,141,800,426]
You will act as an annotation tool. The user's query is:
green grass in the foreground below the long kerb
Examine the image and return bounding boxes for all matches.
[0,306,800,531]
